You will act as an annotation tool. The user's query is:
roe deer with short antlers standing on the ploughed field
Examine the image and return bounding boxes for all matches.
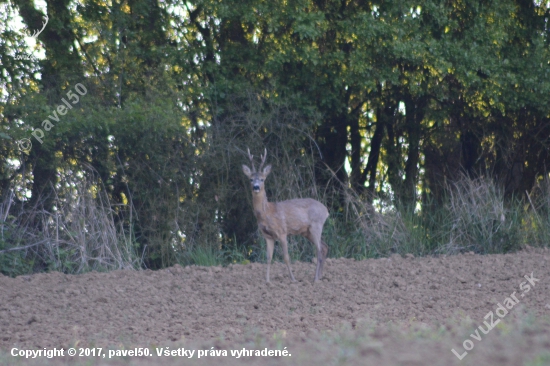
[243,149,328,282]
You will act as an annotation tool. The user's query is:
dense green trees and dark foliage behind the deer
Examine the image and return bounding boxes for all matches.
[0,0,550,273]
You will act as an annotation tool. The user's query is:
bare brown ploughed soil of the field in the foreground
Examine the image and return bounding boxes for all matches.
[0,249,550,365]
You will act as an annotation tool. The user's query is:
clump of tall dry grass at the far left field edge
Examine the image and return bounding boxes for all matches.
[0,170,142,276]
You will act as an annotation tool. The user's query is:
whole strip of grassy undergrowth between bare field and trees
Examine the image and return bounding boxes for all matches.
[0,170,550,276]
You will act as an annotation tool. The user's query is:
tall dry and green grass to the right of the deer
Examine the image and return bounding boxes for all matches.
[325,172,550,259]
